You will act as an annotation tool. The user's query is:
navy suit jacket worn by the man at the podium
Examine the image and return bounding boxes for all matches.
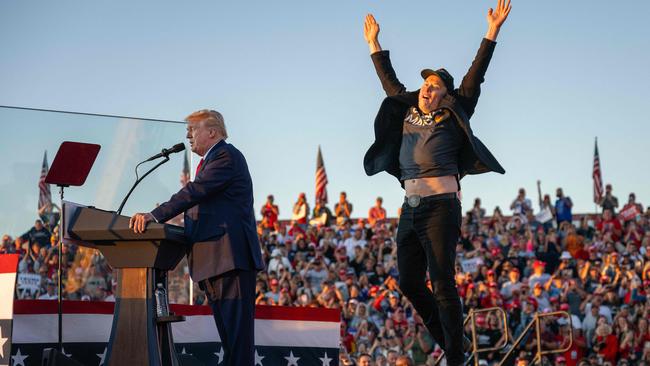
[151,141,264,281]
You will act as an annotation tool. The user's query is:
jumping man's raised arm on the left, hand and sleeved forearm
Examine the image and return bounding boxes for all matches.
[363,14,406,96]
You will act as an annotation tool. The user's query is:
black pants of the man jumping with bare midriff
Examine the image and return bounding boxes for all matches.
[397,194,465,366]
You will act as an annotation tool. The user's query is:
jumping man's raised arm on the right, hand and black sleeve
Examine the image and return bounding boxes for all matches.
[458,0,512,117]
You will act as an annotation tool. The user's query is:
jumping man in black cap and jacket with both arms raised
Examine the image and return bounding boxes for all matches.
[364,0,511,366]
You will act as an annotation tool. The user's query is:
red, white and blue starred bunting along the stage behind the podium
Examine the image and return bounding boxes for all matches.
[8,300,341,366]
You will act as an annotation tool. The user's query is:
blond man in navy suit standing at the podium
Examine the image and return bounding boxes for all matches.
[130,110,264,366]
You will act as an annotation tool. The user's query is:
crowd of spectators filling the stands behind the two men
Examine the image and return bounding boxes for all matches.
[0,185,650,366]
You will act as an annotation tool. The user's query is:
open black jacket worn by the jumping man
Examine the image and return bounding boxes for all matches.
[363,39,505,183]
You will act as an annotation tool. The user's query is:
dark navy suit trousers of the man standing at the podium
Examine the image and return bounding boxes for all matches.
[201,270,256,366]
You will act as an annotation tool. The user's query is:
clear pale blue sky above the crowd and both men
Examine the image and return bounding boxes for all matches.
[0,0,650,232]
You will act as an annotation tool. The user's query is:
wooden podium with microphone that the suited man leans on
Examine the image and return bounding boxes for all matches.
[65,204,187,366]
